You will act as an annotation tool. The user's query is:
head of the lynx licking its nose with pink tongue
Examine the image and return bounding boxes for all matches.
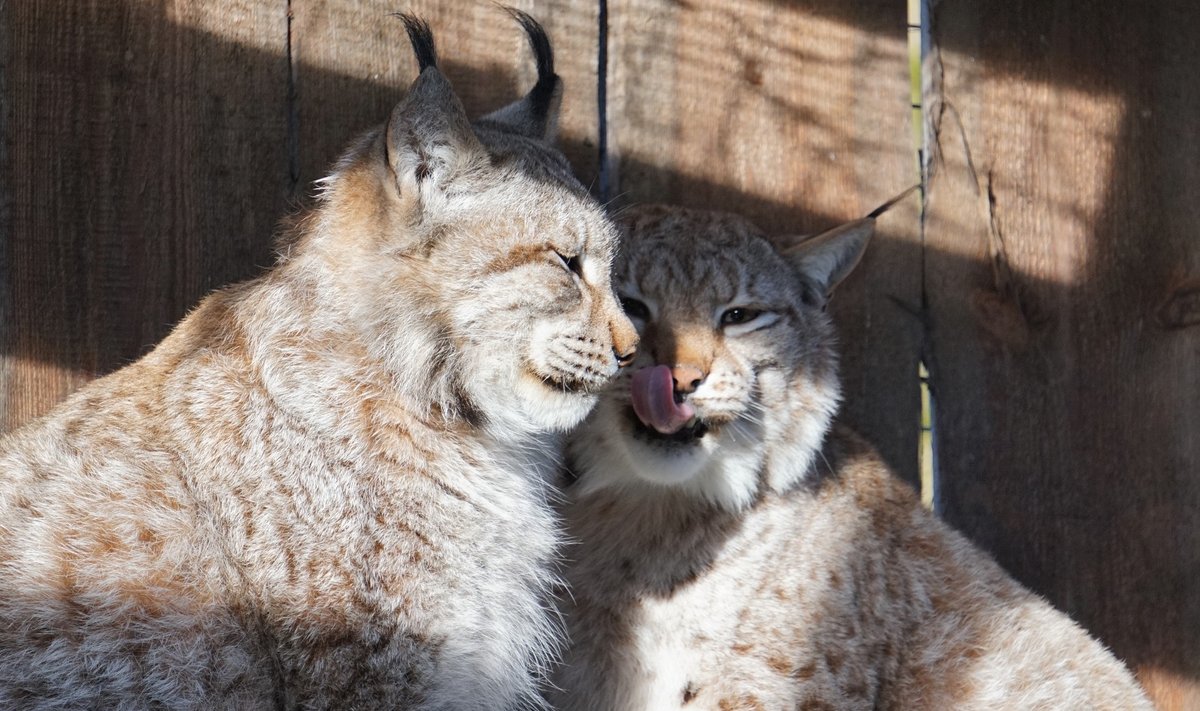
[570,207,875,510]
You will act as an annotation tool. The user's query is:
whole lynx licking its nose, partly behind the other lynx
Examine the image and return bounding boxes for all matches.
[548,207,1150,711]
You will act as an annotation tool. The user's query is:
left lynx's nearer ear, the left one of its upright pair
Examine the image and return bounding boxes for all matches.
[385,14,487,219]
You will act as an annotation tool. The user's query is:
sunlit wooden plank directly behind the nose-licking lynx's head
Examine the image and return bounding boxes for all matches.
[607,0,922,484]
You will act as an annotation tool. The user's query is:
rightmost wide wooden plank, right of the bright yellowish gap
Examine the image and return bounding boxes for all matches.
[926,0,1200,709]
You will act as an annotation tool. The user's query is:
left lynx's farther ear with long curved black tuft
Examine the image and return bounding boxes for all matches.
[479,7,563,142]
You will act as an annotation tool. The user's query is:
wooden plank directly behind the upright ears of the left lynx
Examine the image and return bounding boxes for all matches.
[292,0,598,195]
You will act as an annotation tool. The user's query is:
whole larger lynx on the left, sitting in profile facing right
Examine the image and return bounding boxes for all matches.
[0,11,637,710]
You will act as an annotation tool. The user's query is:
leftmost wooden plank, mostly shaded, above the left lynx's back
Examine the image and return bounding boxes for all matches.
[0,0,287,430]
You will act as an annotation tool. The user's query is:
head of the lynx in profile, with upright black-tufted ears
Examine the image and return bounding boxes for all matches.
[289,11,637,436]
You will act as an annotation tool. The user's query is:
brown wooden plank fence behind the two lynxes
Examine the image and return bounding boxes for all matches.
[0,0,1200,709]
